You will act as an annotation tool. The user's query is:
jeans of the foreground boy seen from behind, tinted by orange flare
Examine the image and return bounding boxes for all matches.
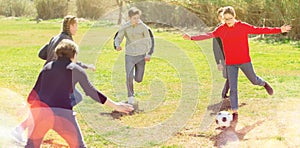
[25,107,86,148]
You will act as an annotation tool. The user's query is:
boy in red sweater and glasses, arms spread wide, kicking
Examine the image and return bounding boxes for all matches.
[183,6,291,128]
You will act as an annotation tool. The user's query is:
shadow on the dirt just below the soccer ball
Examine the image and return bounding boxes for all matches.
[210,120,264,147]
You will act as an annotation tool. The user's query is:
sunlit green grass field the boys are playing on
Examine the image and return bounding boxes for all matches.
[0,18,300,147]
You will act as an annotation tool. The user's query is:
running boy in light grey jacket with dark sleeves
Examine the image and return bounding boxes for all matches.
[114,7,154,104]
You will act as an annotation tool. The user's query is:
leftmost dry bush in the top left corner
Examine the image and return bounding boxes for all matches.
[0,0,36,17]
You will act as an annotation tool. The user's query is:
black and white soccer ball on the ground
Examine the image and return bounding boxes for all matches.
[216,111,232,128]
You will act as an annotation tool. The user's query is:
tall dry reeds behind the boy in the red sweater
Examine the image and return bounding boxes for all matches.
[169,0,300,39]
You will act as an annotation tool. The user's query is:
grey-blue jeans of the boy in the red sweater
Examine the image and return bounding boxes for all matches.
[227,62,265,110]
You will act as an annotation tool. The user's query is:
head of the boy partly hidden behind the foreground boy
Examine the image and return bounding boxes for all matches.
[62,15,78,36]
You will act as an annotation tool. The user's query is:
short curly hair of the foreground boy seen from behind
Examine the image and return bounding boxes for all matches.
[55,39,79,59]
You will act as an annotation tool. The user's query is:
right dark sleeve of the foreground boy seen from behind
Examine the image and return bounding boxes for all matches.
[72,68,107,104]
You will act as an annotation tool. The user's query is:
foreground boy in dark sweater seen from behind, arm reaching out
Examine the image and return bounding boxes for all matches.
[25,39,133,148]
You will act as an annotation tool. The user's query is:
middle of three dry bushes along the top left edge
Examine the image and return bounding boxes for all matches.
[34,0,68,20]
